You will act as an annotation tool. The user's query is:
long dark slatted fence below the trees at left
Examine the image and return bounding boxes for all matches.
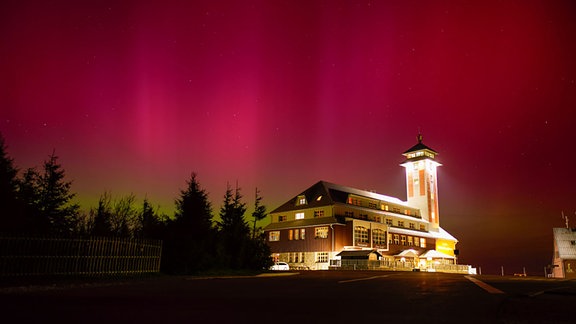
[0,237,162,276]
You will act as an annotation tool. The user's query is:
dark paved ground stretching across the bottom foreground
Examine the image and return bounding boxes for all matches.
[0,271,576,323]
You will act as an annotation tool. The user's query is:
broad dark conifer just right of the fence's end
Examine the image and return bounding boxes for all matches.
[162,173,216,273]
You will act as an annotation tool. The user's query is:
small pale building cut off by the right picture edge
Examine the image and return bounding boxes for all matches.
[552,228,576,279]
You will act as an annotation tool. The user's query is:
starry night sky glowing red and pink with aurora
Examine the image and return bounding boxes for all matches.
[0,0,576,275]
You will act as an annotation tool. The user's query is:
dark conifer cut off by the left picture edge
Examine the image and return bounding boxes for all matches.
[0,134,26,233]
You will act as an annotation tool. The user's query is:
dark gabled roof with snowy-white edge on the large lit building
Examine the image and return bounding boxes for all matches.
[270,181,408,213]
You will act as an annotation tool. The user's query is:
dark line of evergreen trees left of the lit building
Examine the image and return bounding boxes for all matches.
[0,134,271,274]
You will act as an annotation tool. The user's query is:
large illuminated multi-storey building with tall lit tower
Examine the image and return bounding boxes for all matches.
[264,135,458,271]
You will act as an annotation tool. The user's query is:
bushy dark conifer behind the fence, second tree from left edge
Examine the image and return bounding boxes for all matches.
[20,153,80,235]
